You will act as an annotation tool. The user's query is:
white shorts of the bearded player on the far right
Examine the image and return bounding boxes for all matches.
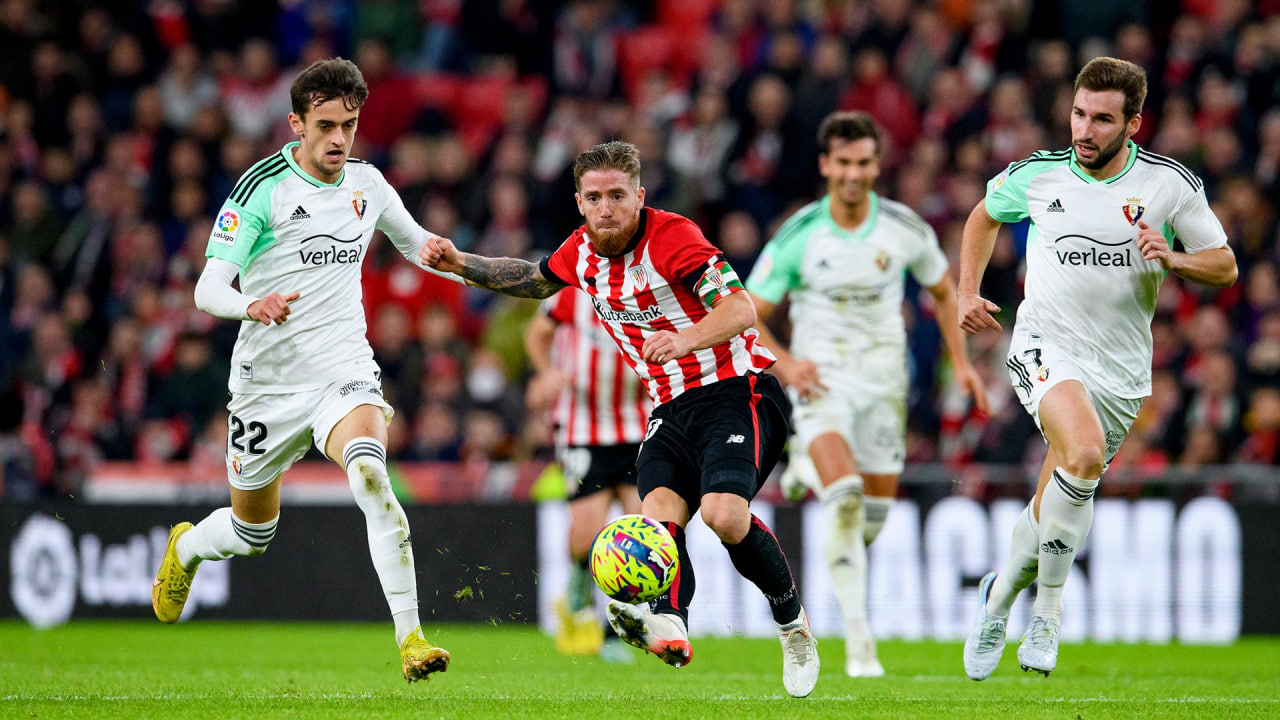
[1005,328,1144,465]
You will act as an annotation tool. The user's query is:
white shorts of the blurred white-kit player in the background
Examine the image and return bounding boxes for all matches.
[791,347,908,475]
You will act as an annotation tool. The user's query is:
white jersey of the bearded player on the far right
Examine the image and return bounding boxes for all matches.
[986,142,1226,397]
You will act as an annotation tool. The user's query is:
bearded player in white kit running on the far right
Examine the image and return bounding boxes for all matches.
[959,58,1236,680]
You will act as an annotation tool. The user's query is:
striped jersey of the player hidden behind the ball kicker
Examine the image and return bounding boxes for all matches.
[541,288,653,447]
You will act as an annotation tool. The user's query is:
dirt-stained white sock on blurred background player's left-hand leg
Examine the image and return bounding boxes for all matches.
[819,474,867,637]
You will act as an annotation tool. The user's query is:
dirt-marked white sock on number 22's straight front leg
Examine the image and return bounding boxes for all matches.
[342,437,420,644]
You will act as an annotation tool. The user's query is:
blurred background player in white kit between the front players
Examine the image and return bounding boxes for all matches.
[746,111,987,678]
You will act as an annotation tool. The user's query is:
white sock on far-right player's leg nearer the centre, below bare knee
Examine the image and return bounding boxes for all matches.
[1034,468,1098,621]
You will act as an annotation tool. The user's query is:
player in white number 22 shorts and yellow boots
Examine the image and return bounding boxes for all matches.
[151,58,449,683]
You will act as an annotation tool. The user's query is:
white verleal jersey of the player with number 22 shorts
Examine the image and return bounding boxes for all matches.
[205,142,429,393]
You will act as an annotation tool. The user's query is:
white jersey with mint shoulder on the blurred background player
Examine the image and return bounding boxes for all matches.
[746,192,947,373]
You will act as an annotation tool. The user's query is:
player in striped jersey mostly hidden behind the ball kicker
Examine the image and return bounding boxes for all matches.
[525,288,653,661]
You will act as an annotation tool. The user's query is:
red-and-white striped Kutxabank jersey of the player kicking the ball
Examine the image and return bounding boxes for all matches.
[541,208,774,405]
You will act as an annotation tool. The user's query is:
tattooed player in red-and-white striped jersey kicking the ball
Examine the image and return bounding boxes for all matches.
[419,141,819,697]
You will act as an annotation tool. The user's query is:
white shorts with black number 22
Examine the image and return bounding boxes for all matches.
[227,373,396,491]
